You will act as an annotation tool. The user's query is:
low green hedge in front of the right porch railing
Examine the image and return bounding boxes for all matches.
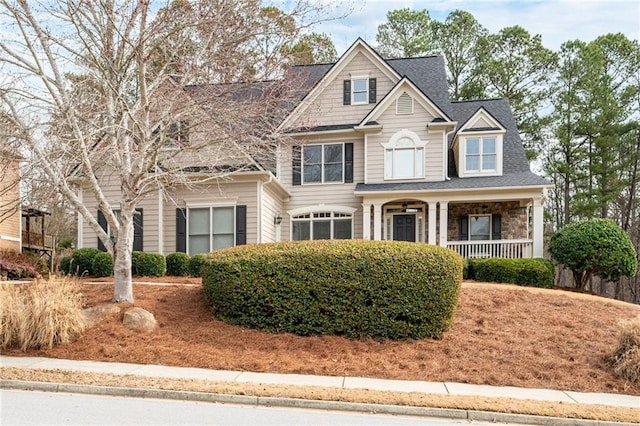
[464,258,555,288]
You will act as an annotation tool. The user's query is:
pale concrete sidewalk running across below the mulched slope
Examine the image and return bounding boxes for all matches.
[0,355,640,412]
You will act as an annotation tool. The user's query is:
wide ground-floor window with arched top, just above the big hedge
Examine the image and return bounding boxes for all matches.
[291,211,353,241]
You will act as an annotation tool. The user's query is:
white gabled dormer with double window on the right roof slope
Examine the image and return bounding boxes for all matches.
[453,107,506,178]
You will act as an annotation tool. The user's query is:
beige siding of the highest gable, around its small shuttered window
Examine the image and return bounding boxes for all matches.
[291,53,395,129]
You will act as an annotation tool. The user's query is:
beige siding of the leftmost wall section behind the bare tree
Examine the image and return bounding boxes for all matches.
[80,171,159,253]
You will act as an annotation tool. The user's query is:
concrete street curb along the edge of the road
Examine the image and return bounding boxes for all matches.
[0,379,637,426]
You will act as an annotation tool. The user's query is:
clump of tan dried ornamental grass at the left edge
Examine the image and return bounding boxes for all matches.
[0,277,87,351]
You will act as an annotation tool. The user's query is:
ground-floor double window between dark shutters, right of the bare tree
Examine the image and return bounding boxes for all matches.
[187,206,235,255]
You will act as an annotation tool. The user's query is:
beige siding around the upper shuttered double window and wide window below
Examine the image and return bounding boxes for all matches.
[280,136,364,241]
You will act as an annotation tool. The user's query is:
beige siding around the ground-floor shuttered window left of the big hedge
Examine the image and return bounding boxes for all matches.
[163,181,258,255]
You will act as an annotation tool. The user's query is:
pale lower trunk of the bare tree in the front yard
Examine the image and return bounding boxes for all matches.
[112,209,133,303]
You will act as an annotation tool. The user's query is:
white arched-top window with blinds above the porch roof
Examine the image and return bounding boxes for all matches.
[382,129,427,179]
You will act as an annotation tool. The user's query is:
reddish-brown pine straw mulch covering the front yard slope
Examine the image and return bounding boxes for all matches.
[3,280,640,395]
